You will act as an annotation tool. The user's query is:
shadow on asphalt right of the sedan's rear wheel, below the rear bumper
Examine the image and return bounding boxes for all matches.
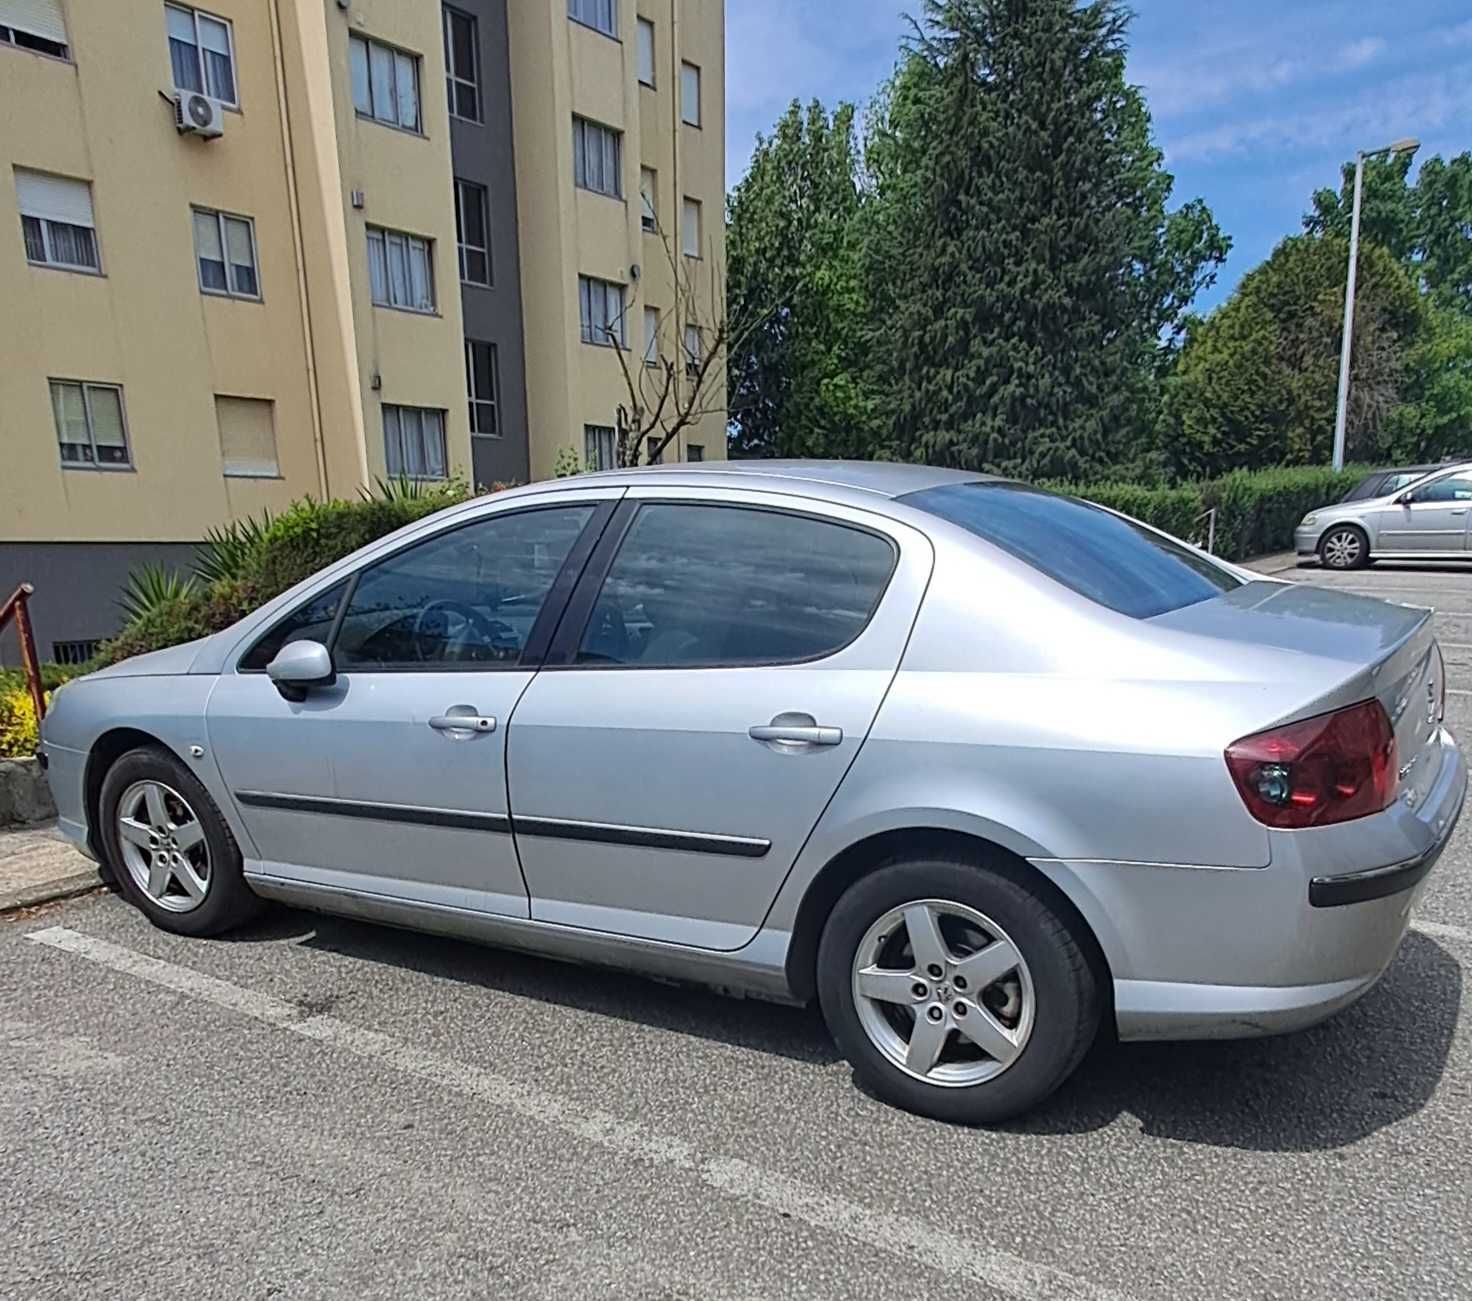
[1007,932,1462,1152]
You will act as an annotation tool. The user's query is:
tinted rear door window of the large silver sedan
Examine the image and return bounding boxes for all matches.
[577,503,896,668]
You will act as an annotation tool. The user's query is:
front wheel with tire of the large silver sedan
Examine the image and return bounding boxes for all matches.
[97,746,265,936]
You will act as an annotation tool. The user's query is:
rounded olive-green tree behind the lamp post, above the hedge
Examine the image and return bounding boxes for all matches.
[1164,235,1424,475]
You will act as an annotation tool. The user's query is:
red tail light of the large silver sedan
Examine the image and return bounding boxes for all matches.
[1226,701,1397,827]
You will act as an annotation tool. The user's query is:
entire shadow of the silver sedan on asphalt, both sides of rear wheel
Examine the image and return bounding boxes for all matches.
[236,908,1462,1151]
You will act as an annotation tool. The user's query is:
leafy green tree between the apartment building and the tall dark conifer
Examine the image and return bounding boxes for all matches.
[727,100,876,458]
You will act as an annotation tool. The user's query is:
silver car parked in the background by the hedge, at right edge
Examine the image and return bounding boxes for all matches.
[1294,464,1472,570]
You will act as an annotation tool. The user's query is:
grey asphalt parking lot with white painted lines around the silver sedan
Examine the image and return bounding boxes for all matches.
[0,567,1472,1301]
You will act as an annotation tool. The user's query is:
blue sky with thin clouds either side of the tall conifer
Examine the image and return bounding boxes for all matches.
[726,0,1472,309]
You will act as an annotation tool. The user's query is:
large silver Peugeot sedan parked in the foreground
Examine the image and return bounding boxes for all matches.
[44,462,1466,1121]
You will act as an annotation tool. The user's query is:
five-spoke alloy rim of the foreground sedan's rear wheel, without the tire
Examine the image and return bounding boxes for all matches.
[851,899,1036,1088]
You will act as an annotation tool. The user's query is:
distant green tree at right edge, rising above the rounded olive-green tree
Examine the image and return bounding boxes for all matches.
[1303,152,1472,315]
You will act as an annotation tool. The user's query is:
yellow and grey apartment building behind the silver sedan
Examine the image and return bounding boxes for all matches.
[0,0,726,659]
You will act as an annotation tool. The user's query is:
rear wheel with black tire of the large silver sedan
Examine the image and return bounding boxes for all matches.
[817,858,1103,1124]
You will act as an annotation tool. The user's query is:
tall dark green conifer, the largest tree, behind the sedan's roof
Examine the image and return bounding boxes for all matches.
[864,0,1229,478]
